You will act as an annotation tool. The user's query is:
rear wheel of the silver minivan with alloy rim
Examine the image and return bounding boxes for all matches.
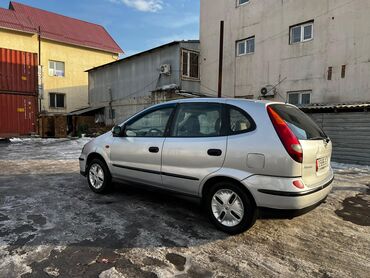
[204,181,257,235]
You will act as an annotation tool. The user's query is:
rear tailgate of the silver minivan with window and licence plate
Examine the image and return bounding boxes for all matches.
[272,104,332,187]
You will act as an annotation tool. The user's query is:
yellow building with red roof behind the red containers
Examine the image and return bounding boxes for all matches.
[0,2,123,113]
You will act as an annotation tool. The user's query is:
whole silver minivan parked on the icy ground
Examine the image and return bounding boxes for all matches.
[79,98,334,234]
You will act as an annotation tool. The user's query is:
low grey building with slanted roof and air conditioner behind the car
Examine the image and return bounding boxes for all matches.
[88,40,200,125]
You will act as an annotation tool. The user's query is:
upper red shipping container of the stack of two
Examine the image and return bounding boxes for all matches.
[0,48,38,94]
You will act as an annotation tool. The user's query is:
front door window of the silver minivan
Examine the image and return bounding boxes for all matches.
[125,107,174,137]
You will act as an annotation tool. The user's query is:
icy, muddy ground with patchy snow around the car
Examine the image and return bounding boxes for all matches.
[0,139,370,278]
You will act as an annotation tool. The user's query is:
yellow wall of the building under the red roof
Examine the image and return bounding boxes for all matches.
[0,29,118,113]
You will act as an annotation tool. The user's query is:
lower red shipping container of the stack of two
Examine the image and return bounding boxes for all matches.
[0,93,38,138]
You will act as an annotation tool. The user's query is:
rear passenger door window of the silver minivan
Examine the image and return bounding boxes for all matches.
[171,103,222,137]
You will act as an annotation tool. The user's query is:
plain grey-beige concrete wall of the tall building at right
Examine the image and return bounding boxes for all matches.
[200,0,370,103]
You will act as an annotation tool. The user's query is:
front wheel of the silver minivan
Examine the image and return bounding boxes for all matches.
[86,159,112,194]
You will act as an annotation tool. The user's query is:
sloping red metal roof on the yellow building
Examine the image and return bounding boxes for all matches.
[0,1,123,53]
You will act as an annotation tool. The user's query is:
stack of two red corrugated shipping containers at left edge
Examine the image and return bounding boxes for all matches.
[0,48,38,138]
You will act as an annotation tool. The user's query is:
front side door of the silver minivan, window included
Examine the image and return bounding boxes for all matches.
[110,104,175,187]
